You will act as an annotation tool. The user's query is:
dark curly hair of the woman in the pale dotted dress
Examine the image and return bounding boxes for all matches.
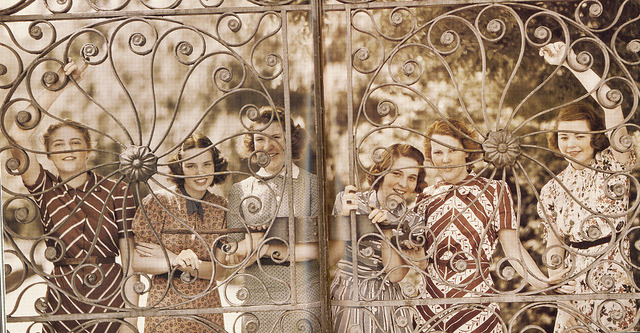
[242,106,307,161]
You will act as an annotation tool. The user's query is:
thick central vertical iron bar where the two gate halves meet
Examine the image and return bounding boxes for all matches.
[311,0,332,332]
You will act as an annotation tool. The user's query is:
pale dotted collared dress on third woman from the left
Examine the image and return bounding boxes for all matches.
[227,166,324,332]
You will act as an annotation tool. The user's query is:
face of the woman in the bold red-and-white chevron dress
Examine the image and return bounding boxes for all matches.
[430,134,469,184]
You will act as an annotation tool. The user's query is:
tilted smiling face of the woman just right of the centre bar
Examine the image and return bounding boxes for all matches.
[378,156,420,208]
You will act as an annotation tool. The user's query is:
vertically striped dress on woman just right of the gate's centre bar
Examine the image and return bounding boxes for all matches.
[330,191,410,333]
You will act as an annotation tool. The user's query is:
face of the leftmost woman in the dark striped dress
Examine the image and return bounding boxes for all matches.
[48,126,89,179]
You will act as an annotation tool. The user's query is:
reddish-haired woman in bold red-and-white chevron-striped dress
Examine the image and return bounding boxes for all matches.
[416,119,548,333]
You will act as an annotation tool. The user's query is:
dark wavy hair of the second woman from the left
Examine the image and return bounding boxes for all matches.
[169,133,229,186]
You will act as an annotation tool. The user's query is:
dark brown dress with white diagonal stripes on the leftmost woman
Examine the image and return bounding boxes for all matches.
[25,165,135,333]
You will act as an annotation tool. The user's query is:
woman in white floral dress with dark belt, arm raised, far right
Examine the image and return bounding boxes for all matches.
[538,42,637,332]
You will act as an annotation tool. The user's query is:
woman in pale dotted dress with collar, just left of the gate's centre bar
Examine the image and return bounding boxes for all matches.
[227,107,323,332]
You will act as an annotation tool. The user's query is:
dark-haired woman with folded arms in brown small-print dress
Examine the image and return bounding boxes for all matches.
[133,134,227,332]
